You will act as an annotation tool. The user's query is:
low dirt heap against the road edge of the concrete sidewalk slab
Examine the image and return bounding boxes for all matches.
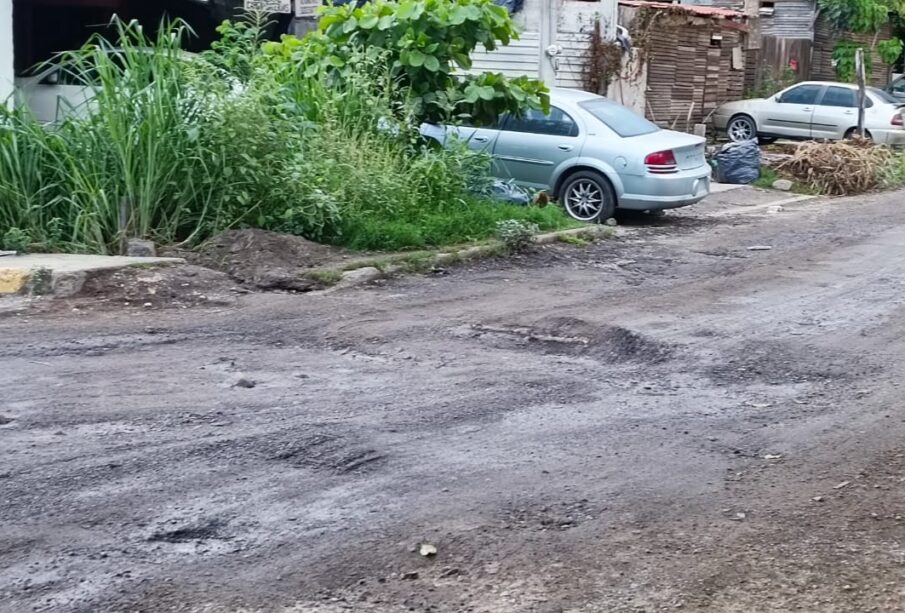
[74,265,238,308]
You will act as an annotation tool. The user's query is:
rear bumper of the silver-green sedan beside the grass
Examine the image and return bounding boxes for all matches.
[619,166,710,211]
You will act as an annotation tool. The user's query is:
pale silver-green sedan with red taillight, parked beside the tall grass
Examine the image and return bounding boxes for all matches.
[422,89,710,222]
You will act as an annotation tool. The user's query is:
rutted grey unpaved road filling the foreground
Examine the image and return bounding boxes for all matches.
[0,193,905,613]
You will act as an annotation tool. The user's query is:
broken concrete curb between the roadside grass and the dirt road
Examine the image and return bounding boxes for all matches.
[320,225,616,294]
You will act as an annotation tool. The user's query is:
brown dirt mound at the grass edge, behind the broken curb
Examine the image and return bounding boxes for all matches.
[167,228,351,292]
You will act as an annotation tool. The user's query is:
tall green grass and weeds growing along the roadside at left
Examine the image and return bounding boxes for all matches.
[0,16,568,253]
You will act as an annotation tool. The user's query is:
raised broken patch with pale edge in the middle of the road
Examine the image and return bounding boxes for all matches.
[458,317,674,364]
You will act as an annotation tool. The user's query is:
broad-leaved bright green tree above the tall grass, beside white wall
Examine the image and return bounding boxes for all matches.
[265,0,549,123]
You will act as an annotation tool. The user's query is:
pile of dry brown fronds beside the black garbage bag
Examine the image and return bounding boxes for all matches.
[776,139,894,196]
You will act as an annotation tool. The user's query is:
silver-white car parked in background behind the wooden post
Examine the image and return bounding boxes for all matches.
[713,81,905,146]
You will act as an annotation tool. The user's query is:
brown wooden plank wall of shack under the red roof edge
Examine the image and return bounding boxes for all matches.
[647,18,746,131]
